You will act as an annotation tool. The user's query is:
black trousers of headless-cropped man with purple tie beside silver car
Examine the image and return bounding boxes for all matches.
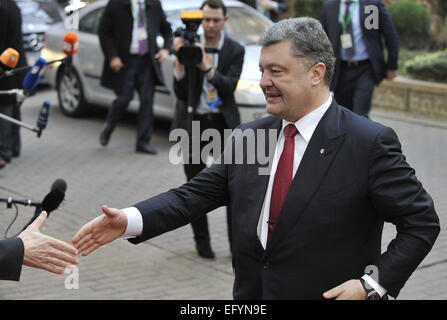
[107,55,154,146]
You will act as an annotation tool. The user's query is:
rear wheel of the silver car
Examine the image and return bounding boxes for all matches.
[57,67,88,117]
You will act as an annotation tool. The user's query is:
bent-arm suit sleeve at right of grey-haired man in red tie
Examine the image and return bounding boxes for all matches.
[369,128,440,297]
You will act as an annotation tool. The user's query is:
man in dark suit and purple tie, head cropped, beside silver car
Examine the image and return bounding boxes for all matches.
[98,0,172,154]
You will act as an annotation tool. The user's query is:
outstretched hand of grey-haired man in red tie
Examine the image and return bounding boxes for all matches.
[71,205,127,256]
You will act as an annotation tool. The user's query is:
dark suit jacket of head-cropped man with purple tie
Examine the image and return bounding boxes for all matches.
[98,0,172,91]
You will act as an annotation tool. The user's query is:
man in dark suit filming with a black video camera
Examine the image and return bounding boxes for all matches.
[174,0,245,259]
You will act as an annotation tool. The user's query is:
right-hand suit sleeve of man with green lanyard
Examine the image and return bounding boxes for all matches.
[378,1,399,70]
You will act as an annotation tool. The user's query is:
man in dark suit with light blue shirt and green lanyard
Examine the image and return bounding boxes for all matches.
[321,0,399,117]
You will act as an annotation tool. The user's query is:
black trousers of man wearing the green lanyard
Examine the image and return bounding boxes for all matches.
[334,60,375,117]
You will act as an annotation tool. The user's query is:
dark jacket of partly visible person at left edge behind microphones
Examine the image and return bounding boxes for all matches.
[0,0,27,103]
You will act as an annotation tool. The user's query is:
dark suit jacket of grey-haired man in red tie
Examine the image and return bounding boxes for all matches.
[131,101,440,299]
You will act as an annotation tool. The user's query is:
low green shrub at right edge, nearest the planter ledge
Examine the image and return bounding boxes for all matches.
[404,49,447,82]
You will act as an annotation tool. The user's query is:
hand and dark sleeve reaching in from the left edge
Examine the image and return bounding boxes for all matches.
[0,212,79,281]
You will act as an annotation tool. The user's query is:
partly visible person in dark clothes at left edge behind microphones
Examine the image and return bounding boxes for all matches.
[0,0,27,169]
